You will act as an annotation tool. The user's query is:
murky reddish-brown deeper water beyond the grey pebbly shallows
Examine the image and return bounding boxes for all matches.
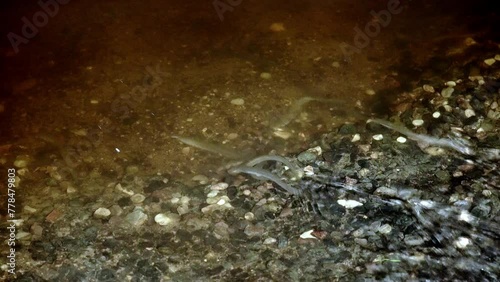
[2,1,491,185]
